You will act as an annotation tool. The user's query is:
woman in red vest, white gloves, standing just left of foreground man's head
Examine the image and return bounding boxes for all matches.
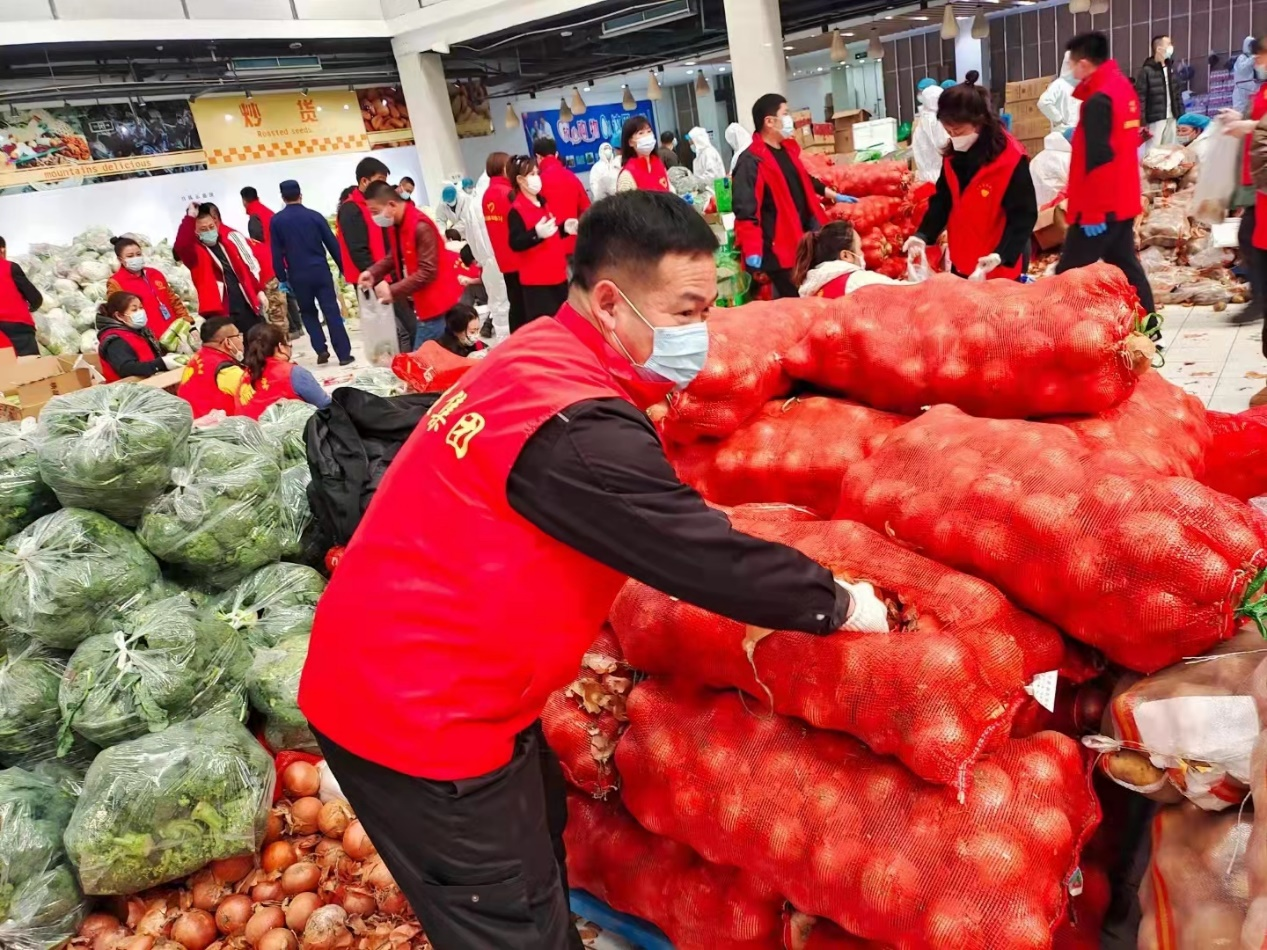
[507,155,578,322]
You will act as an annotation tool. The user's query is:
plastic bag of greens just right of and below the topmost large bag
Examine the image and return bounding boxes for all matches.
[137,438,283,588]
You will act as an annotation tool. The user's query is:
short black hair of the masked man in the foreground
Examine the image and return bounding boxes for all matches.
[571,191,717,290]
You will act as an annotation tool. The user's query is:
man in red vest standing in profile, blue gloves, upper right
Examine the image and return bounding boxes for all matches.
[1055,33,1156,313]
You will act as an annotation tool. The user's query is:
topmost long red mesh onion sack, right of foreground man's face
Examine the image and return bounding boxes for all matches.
[784,263,1154,419]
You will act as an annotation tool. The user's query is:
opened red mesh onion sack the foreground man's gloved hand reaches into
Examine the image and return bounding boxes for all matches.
[611,509,1063,790]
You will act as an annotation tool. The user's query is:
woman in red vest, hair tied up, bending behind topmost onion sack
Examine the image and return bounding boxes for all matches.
[902,72,1038,280]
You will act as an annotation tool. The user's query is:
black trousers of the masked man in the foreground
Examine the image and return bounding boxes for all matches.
[317,722,583,950]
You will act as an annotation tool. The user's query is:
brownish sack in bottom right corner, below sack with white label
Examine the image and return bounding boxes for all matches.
[1138,803,1261,950]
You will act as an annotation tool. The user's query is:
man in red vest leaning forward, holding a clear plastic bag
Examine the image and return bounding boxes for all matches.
[359,181,462,350]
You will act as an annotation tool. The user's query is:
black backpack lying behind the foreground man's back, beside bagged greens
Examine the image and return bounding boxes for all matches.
[304,386,441,547]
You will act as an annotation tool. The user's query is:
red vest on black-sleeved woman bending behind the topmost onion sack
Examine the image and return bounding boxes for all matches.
[941,132,1025,280]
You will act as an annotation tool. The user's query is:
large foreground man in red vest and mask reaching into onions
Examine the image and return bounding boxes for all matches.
[299,191,888,950]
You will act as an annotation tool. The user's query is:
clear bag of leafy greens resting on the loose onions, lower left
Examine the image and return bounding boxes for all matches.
[65,713,276,894]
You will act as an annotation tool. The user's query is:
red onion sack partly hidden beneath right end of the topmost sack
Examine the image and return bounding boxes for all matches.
[1052,372,1211,480]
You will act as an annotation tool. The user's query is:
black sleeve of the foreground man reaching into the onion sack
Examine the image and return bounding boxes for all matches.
[507,399,850,633]
